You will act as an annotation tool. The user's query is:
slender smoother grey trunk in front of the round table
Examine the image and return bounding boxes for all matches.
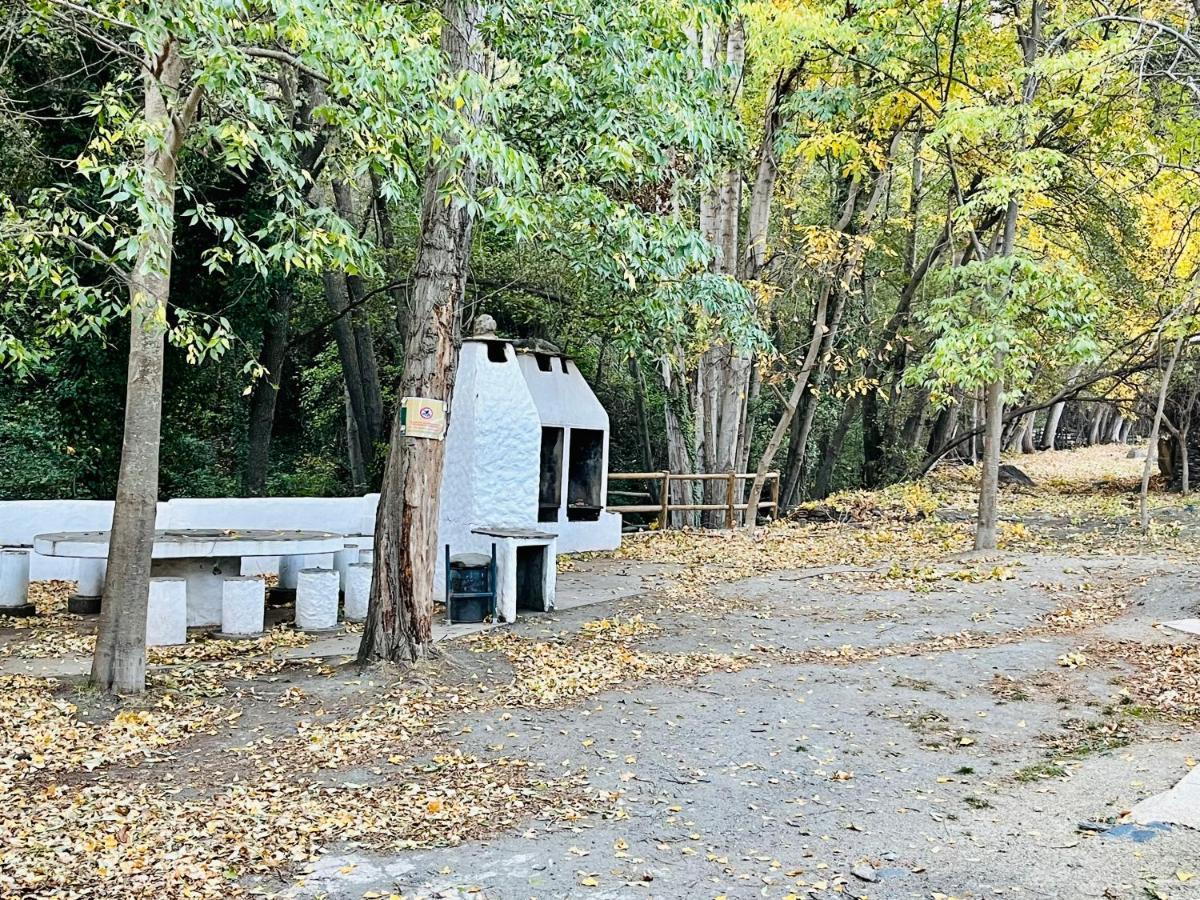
[91,37,199,694]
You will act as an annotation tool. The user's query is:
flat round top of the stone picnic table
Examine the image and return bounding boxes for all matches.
[34,528,346,559]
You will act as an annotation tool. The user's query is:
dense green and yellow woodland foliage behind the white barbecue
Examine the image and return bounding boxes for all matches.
[0,0,1200,502]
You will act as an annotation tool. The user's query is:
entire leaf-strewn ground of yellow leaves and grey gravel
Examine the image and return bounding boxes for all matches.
[7,448,1200,900]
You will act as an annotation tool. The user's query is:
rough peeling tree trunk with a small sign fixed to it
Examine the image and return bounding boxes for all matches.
[359,0,482,664]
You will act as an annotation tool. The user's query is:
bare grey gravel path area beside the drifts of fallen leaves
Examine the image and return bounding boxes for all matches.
[276,557,1200,900]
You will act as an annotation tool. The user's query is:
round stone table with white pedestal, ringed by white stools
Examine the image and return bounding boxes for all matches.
[34,528,346,628]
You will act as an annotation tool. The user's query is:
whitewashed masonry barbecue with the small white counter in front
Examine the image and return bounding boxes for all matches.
[437,335,620,622]
